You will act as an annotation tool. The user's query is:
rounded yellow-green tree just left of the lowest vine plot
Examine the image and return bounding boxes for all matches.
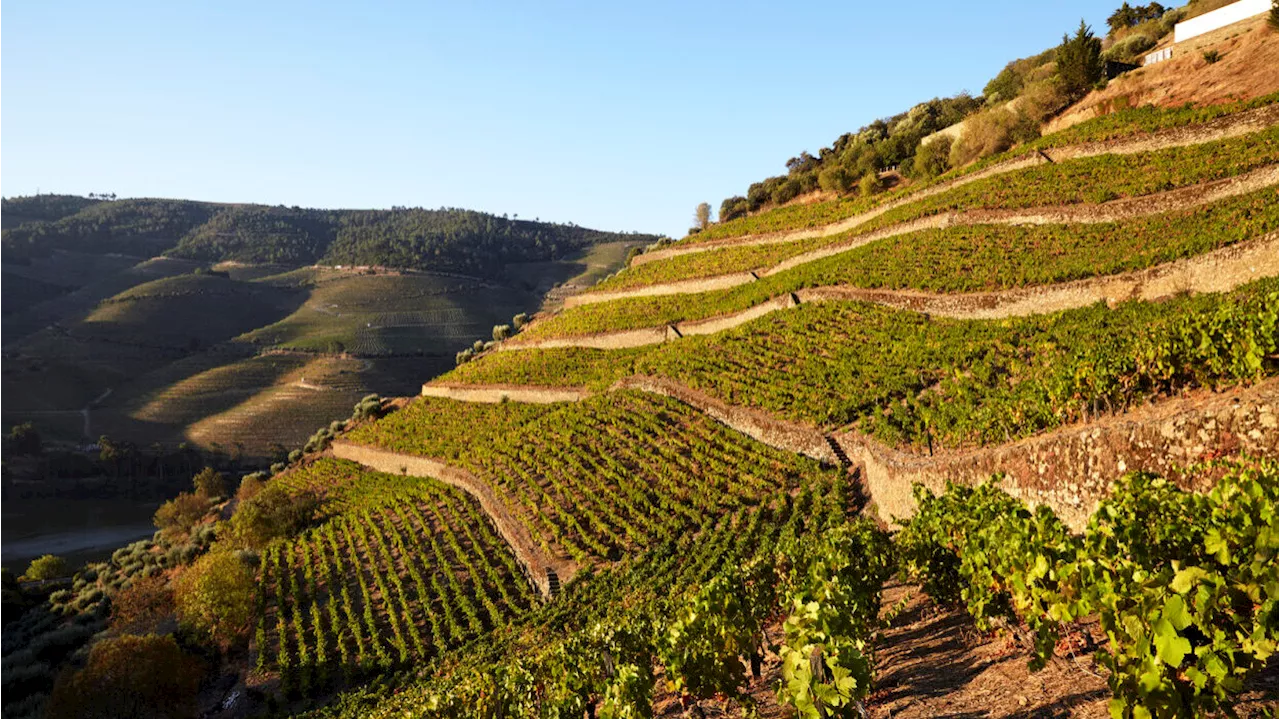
[174,550,257,646]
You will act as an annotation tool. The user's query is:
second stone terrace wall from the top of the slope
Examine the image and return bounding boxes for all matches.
[564,165,1280,307]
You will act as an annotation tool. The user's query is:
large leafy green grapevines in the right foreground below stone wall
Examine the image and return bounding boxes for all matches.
[900,462,1280,719]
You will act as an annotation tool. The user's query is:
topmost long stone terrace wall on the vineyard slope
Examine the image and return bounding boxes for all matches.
[632,104,1280,266]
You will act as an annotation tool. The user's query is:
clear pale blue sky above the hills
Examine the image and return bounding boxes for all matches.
[0,0,1119,235]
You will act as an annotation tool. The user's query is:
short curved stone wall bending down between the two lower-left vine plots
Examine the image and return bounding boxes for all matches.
[332,440,577,597]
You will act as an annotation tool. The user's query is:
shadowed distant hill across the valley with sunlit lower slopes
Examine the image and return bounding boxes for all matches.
[0,194,654,459]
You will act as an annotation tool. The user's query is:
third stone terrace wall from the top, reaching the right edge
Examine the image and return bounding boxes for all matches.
[498,233,1280,352]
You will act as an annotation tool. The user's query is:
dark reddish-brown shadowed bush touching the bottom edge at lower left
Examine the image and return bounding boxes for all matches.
[45,635,205,719]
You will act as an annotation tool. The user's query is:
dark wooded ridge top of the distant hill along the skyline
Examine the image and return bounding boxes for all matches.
[0,196,657,278]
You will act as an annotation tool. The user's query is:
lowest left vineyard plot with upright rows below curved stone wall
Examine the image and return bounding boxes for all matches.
[257,459,535,695]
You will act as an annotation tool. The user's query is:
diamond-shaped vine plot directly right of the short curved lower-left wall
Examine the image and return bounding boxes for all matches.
[462,393,834,564]
